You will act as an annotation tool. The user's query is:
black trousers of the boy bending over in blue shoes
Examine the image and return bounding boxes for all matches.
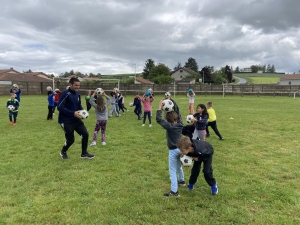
[189,155,216,186]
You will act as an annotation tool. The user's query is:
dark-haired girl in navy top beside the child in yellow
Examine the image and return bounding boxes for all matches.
[192,104,208,141]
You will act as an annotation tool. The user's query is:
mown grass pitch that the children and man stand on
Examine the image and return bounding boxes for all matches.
[0,92,300,224]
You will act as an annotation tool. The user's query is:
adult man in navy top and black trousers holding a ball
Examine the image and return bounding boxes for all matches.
[57,77,94,159]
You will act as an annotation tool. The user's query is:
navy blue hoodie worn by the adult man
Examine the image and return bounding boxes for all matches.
[57,88,83,123]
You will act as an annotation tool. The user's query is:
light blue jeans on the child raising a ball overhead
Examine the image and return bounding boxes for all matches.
[169,148,184,192]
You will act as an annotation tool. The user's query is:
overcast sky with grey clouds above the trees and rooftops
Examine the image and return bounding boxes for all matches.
[0,0,300,74]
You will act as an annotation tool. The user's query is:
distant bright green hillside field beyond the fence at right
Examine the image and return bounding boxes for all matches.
[234,73,285,84]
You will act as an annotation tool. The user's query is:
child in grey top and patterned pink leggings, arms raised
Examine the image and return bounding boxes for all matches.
[90,91,110,146]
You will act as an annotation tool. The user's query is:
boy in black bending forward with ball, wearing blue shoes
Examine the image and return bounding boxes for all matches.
[177,136,218,195]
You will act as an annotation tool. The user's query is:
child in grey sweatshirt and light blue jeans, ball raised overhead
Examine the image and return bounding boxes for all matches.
[156,100,185,197]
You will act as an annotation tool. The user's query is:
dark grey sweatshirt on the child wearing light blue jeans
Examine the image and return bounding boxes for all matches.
[156,110,183,150]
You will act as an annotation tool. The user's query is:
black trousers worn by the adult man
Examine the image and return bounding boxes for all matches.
[60,119,89,154]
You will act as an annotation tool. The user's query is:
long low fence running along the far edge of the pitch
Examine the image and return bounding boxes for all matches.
[0,82,300,96]
